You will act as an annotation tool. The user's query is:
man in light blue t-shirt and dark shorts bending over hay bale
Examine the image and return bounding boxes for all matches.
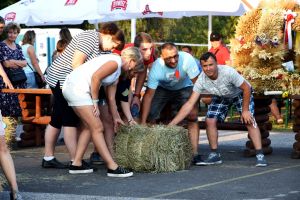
[141,43,202,162]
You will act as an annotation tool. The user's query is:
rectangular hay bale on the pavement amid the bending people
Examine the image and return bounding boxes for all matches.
[114,125,193,172]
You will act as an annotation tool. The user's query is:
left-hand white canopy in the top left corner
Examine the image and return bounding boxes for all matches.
[0,0,104,26]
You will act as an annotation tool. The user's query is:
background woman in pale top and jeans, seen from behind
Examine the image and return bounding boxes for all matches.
[22,30,45,88]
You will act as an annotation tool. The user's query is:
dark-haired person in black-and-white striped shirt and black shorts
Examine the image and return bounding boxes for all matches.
[42,23,125,168]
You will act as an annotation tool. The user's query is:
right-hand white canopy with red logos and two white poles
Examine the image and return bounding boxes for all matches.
[99,0,259,44]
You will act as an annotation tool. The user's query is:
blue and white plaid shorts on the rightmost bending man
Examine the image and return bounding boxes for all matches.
[206,93,254,122]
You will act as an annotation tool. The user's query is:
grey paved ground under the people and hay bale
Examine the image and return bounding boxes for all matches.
[0,131,300,200]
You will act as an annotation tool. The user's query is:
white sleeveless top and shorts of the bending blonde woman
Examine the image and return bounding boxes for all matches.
[62,54,122,106]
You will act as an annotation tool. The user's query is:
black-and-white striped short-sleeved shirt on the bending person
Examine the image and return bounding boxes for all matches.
[46,30,100,88]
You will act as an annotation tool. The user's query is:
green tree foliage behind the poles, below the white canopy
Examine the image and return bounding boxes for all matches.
[113,16,238,57]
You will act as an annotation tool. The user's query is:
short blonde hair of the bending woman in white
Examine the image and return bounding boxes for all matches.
[121,47,144,71]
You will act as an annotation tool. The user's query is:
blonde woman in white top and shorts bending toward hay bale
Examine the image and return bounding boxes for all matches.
[62,47,143,177]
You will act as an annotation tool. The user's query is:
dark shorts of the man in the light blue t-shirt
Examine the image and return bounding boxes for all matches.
[148,86,193,121]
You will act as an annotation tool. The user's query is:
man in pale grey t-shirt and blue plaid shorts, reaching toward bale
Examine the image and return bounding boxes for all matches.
[170,52,267,167]
